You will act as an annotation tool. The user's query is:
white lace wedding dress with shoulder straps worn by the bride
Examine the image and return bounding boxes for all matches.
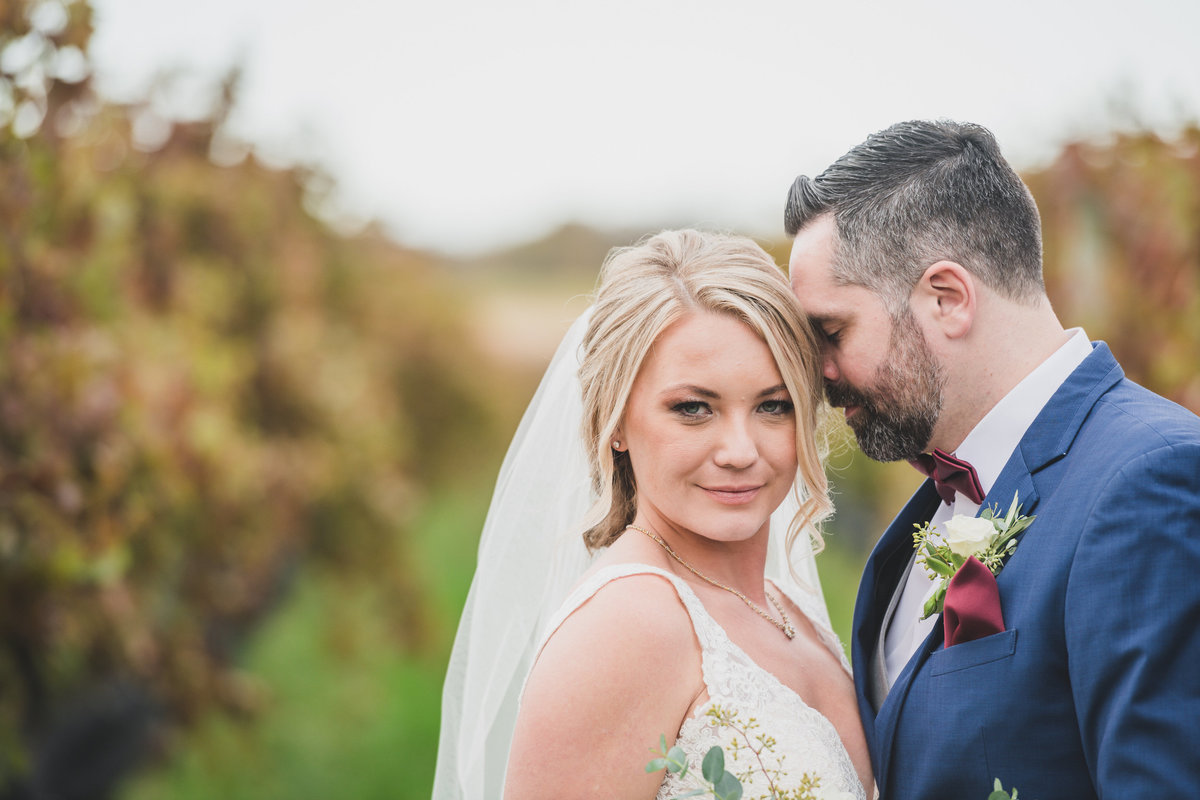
[546,564,865,800]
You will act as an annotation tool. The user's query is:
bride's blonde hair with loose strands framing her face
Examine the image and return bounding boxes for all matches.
[580,230,833,566]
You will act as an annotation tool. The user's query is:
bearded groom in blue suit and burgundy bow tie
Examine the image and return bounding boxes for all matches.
[786,121,1200,800]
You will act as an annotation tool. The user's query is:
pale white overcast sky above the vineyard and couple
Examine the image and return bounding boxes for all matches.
[92,0,1200,252]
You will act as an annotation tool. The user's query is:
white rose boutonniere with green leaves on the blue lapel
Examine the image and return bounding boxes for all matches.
[912,494,1036,619]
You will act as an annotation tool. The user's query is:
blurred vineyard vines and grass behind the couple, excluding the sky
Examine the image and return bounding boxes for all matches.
[0,0,1200,800]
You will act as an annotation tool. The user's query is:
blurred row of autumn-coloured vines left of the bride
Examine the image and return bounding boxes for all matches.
[0,0,511,787]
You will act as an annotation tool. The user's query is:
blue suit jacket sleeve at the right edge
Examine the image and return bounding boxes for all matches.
[1064,443,1200,800]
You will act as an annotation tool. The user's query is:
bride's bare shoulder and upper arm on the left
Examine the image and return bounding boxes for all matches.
[506,570,704,796]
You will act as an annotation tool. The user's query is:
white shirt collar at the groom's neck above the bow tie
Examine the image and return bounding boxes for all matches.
[954,327,1092,513]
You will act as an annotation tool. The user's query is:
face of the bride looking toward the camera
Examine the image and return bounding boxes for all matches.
[619,312,796,541]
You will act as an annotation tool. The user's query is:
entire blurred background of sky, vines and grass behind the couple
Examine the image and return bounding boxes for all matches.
[0,0,1200,800]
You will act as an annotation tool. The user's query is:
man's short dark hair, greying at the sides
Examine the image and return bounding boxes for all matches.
[784,120,1045,315]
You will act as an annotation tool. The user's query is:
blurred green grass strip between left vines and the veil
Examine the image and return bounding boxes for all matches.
[122,568,445,800]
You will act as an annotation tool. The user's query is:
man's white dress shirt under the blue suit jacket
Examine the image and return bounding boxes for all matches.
[883,327,1092,688]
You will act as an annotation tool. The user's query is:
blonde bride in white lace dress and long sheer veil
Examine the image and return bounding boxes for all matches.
[433,230,874,800]
